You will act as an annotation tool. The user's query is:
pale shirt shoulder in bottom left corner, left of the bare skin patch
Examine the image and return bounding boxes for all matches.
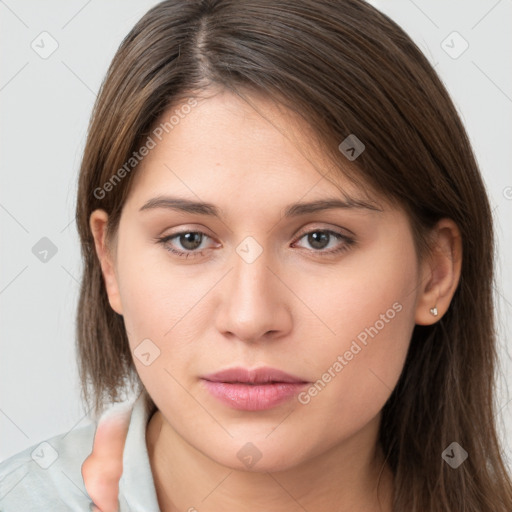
[0,423,96,512]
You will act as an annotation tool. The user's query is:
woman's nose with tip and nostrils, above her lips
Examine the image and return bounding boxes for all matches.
[216,244,293,343]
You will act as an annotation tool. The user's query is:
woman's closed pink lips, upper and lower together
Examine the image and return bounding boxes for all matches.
[202,367,309,411]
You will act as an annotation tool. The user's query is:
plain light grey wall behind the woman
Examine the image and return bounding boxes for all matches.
[0,0,512,467]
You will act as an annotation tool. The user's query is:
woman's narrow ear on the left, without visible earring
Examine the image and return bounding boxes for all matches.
[89,210,123,315]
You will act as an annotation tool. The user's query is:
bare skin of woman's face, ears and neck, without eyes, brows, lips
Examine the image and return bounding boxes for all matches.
[84,92,461,512]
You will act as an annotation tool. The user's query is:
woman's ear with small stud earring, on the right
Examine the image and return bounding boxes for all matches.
[415,219,462,325]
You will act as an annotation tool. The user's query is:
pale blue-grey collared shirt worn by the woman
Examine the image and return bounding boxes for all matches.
[0,392,160,512]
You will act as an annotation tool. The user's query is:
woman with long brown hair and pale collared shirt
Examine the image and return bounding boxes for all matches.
[2,0,512,512]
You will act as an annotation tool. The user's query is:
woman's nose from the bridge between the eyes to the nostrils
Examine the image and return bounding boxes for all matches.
[217,237,291,341]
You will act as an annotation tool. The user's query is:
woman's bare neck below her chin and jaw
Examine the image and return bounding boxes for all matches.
[146,410,393,512]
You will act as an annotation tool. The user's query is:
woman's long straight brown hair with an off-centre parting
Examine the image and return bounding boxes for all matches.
[77,0,512,512]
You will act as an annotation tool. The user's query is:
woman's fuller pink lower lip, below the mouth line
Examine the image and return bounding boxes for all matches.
[203,379,308,411]
